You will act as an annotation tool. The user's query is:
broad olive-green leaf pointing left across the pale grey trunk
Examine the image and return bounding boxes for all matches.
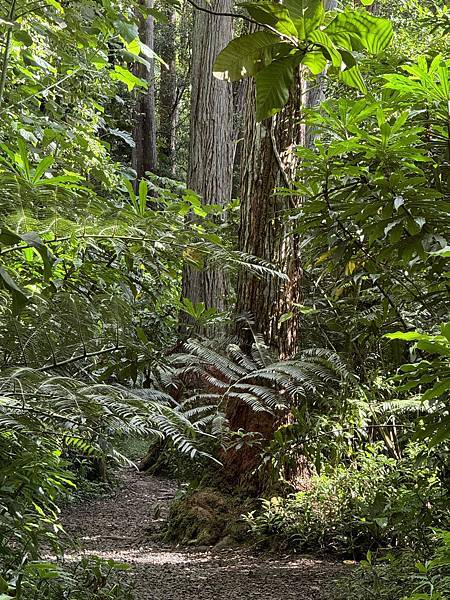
[213,31,280,81]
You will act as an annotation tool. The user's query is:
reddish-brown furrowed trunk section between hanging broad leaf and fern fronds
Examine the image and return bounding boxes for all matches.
[236,72,305,357]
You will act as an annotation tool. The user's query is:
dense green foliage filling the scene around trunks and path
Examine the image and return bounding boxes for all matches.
[0,0,450,600]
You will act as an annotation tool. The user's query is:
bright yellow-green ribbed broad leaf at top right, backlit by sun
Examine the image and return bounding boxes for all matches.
[324,10,393,54]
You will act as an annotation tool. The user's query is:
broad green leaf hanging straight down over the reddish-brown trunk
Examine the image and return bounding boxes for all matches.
[255,58,294,121]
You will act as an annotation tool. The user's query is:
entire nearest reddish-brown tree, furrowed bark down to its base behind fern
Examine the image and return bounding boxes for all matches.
[224,0,336,485]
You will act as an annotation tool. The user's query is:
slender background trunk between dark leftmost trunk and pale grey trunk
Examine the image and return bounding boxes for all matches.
[157,11,178,177]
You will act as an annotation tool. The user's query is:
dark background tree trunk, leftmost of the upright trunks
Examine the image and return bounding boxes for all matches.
[132,0,158,181]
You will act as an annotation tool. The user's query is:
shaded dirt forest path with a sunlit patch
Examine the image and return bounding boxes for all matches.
[62,469,343,600]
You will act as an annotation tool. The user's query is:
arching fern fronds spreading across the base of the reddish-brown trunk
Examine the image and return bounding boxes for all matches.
[172,339,352,426]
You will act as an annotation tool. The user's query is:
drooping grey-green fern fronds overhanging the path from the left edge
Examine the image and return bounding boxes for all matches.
[0,368,206,454]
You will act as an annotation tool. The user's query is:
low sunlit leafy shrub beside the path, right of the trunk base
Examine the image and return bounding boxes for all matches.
[245,445,449,555]
